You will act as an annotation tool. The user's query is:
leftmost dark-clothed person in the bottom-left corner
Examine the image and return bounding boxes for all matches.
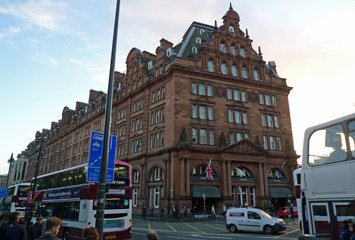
[0,212,27,240]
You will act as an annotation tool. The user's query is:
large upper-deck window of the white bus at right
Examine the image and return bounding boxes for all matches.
[308,124,346,166]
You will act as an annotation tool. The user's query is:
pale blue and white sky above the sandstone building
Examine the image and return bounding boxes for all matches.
[0,0,355,174]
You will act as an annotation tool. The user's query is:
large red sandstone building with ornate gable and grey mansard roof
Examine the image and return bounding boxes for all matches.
[27,6,297,216]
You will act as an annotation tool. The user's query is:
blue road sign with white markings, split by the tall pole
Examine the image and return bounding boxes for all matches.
[86,131,117,182]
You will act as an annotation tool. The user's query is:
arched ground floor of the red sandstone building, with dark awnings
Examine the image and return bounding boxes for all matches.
[131,141,296,215]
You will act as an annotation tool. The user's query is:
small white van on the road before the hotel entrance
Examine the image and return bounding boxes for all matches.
[226,208,286,234]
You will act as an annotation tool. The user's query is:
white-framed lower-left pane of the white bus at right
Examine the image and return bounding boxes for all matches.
[310,202,331,236]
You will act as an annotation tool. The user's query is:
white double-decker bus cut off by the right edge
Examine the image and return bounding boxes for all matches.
[298,113,355,239]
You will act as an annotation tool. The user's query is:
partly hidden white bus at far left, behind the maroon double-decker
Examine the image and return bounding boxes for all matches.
[3,183,31,217]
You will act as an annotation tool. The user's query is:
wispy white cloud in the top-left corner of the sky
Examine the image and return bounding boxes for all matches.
[0,0,66,30]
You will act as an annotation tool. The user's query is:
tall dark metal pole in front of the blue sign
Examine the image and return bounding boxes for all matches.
[95,0,120,240]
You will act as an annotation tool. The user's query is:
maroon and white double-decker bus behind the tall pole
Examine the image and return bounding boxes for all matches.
[34,160,132,240]
